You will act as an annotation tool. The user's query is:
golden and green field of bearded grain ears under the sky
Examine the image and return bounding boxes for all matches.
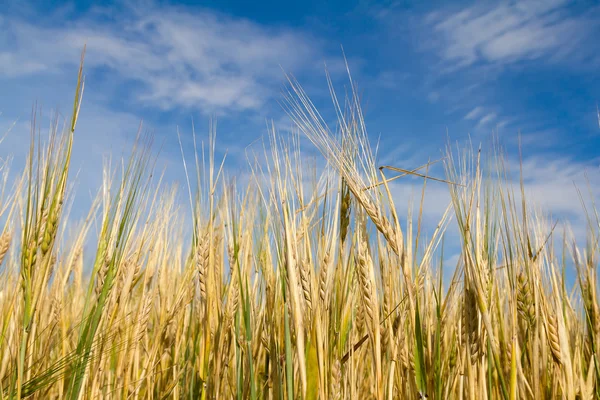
[0,51,600,400]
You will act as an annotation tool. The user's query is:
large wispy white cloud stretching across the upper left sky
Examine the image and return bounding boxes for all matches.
[0,5,319,113]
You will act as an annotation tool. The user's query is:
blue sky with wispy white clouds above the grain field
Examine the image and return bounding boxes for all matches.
[0,0,600,253]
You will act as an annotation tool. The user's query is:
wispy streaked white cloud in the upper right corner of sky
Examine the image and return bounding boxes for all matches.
[425,0,599,67]
